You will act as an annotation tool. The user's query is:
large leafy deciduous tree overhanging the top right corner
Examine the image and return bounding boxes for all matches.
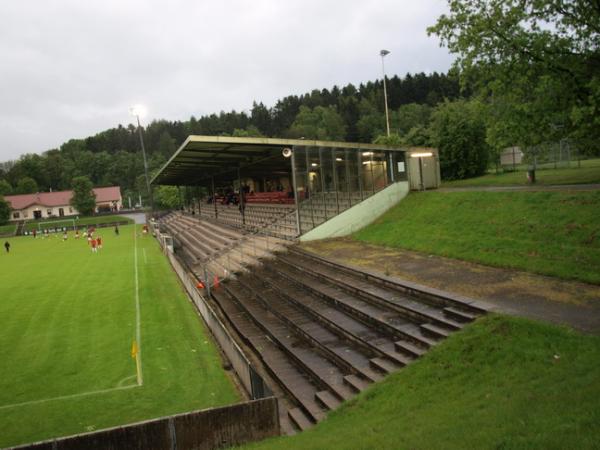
[428,0,600,144]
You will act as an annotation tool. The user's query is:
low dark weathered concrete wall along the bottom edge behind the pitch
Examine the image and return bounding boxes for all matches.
[12,397,279,450]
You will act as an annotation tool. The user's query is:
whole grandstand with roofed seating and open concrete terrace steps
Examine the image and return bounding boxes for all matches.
[153,136,485,433]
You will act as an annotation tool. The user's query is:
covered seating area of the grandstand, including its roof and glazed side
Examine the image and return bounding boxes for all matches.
[152,136,407,238]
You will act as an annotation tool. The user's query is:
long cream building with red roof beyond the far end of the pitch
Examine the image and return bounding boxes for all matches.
[4,186,123,221]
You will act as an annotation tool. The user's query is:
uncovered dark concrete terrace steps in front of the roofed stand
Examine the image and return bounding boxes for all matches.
[212,247,484,430]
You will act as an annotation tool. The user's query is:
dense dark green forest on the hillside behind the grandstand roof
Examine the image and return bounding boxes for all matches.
[0,73,460,202]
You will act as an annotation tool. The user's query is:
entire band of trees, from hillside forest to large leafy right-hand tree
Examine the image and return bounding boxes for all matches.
[0,0,600,220]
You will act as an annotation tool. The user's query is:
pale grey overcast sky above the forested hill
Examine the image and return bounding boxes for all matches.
[0,0,452,161]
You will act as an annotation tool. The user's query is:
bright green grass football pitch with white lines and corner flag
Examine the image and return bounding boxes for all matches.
[0,225,240,447]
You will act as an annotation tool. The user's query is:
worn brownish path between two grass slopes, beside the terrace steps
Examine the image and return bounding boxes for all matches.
[302,239,600,334]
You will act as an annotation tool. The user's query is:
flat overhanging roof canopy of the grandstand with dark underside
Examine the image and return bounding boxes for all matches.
[151,136,406,186]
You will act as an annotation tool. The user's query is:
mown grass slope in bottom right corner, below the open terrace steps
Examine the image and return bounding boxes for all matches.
[245,316,600,450]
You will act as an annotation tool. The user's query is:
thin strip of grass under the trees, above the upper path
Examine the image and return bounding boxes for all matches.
[442,159,600,187]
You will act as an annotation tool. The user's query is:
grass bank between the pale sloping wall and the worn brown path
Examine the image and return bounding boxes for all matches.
[354,191,600,284]
